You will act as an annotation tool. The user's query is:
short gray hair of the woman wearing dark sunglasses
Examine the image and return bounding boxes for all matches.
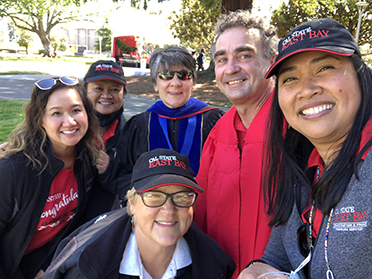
[150,46,196,85]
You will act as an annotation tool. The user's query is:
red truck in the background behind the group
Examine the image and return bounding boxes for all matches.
[111,35,151,68]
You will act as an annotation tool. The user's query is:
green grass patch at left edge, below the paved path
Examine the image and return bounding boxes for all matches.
[0,99,27,143]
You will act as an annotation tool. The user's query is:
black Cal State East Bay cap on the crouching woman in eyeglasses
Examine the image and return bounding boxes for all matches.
[131,148,204,193]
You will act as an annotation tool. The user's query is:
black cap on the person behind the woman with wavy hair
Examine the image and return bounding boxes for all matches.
[84,60,127,85]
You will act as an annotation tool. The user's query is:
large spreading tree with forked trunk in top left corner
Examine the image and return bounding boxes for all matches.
[0,0,81,55]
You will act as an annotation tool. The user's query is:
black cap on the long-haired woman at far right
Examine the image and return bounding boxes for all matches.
[265,18,361,78]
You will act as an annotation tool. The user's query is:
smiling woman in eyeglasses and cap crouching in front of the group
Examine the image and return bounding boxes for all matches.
[43,148,235,279]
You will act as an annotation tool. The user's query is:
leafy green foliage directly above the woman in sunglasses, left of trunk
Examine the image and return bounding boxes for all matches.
[168,0,221,54]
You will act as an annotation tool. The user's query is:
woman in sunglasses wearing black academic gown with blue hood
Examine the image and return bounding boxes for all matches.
[110,46,223,207]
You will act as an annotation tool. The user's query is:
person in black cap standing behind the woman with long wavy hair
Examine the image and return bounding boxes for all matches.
[84,60,127,214]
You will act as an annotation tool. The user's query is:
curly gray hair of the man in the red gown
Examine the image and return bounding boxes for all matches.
[212,10,279,59]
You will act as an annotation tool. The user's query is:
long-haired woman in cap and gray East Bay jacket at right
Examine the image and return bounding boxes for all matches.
[240,18,372,279]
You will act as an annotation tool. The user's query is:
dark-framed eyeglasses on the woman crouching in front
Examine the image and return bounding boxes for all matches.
[137,191,198,207]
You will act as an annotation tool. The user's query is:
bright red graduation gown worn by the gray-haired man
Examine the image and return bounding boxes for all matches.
[195,95,272,278]
